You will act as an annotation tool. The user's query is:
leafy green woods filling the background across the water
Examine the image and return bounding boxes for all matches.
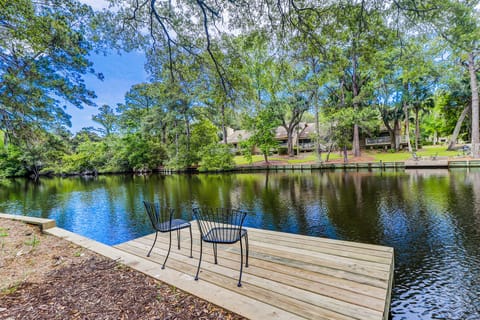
[0,0,480,178]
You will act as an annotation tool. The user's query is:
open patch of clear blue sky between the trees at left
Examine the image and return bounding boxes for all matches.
[67,52,147,133]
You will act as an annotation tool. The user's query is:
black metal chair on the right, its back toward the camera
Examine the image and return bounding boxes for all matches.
[193,208,248,287]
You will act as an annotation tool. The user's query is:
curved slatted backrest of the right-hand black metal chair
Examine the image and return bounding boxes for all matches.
[193,208,247,239]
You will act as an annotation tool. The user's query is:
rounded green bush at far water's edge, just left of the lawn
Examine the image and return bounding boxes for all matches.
[199,143,235,171]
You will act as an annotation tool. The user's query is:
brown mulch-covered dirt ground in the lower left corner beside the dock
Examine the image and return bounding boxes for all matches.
[0,219,246,319]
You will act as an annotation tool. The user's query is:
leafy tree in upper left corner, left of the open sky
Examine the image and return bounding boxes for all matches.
[0,0,95,141]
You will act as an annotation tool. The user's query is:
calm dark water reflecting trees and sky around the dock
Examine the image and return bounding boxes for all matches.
[0,170,480,319]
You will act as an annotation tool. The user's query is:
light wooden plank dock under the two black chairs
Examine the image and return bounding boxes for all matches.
[115,222,394,320]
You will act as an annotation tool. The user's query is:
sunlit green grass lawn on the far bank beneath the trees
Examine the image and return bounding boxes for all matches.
[234,146,461,166]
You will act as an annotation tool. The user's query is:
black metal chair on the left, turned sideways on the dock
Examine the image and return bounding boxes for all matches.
[143,201,193,269]
